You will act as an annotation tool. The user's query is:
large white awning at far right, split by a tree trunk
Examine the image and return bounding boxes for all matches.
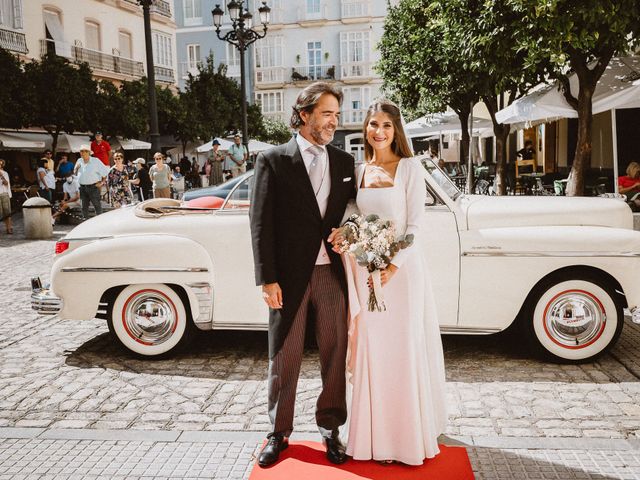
[496,55,640,124]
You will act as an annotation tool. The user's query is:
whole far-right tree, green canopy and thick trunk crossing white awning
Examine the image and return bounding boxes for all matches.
[509,0,640,195]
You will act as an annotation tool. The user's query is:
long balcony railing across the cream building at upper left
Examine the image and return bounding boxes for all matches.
[40,39,144,78]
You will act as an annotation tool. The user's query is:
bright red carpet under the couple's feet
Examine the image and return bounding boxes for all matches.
[249,442,474,480]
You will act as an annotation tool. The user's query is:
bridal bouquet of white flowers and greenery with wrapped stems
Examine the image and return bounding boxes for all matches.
[337,214,413,312]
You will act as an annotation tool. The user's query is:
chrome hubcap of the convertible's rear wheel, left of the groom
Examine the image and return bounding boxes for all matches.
[124,292,177,345]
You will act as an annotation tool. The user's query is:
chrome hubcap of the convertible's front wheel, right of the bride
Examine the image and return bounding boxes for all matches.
[544,291,607,348]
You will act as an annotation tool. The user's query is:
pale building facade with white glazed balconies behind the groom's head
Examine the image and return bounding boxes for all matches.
[254,0,387,161]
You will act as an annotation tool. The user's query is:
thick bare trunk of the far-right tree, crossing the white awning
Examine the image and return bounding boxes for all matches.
[566,84,595,197]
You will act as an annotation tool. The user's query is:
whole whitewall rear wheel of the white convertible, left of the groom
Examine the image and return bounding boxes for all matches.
[108,284,195,358]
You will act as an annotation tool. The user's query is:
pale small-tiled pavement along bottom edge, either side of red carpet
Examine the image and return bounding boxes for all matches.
[0,439,640,480]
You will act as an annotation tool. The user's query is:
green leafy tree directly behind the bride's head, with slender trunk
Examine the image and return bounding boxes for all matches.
[377,0,480,191]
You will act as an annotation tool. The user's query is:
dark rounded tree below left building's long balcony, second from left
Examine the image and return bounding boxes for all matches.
[24,54,97,153]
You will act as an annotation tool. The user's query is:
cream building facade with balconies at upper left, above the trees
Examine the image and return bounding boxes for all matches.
[0,0,177,86]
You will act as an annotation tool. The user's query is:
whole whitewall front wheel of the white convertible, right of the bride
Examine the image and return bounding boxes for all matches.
[523,275,624,363]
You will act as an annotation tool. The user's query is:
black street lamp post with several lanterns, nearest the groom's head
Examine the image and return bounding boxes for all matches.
[211,0,271,152]
